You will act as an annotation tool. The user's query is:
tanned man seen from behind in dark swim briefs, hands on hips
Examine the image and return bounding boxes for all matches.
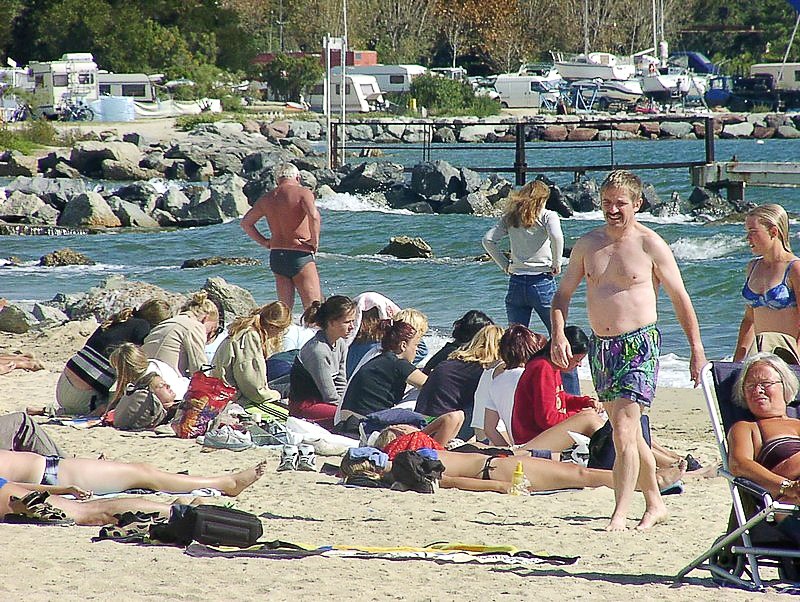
[241,163,322,309]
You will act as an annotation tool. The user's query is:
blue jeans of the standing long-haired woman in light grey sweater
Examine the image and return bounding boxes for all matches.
[506,274,581,395]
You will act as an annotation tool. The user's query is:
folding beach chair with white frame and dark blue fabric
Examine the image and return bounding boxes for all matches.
[676,362,800,591]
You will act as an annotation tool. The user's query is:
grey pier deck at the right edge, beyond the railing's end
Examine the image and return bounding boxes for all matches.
[689,158,800,201]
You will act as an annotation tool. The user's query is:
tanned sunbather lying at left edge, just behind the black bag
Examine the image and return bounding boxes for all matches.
[0,478,192,526]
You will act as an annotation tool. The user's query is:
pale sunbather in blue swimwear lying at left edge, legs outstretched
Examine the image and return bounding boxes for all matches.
[0,450,266,498]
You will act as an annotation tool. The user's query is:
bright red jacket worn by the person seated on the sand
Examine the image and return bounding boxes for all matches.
[510,357,593,444]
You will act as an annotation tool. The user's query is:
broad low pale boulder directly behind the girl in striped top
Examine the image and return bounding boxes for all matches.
[65,276,186,322]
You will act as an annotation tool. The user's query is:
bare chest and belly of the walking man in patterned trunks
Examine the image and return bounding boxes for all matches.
[576,223,666,336]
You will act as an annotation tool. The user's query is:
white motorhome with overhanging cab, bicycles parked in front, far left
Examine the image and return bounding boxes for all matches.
[28,52,100,115]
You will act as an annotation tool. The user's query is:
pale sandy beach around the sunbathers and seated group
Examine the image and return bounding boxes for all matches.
[0,321,777,602]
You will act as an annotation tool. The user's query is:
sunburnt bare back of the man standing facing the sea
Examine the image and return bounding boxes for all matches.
[254,182,317,253]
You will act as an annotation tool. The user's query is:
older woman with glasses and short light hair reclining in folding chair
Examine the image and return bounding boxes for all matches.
[728,353,800,504]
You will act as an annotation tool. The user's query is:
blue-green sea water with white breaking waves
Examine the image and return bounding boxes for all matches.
[0,140,800,386]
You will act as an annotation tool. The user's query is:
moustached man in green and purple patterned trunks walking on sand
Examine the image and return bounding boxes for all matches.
[551,171,706,531]
